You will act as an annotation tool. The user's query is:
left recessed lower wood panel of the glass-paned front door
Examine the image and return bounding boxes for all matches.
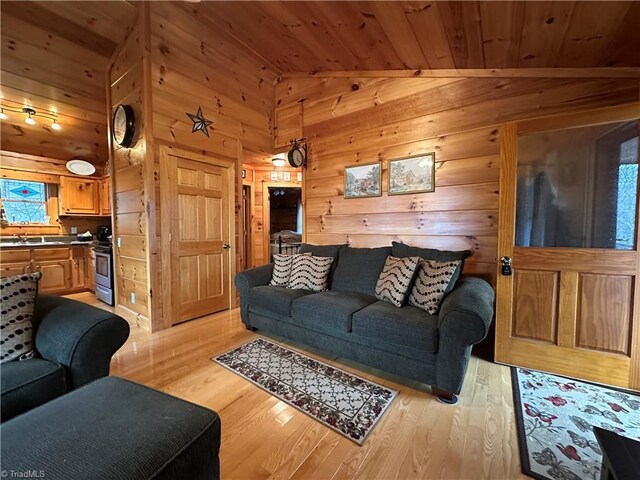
[512,270,559,343]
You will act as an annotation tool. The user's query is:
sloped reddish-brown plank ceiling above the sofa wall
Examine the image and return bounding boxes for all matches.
[198,1,640,73]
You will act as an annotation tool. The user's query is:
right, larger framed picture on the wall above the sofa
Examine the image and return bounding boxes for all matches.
[389,153,436,195]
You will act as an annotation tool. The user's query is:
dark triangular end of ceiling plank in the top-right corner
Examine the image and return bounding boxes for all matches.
[599,2,640,67]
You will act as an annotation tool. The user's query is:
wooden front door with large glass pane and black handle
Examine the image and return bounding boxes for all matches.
[496,110,640,389]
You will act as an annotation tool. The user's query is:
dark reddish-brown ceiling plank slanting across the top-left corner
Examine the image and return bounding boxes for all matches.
[0,2,117,58]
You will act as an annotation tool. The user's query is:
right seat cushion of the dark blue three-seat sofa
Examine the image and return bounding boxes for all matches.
[351,301,438,354]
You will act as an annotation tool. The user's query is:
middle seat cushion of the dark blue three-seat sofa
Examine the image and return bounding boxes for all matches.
[291,291,376,332]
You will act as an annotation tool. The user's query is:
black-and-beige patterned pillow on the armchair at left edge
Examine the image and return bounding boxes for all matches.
[0,272,41,363]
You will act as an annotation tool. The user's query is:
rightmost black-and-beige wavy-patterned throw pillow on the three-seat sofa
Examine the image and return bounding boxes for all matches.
[409,260,461,315]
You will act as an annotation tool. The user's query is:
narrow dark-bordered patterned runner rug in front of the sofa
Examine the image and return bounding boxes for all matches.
[212,338,398,445]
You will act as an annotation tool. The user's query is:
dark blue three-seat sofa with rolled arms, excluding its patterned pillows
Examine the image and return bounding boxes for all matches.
[235,243,494,403]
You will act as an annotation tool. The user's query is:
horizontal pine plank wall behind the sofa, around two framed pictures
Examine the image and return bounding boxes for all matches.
[276,77,638,283]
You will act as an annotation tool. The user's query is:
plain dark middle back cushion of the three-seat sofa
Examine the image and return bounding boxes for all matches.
[331,247,391,297]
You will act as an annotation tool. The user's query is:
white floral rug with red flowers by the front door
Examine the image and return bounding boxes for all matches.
[511,368,640,480]
